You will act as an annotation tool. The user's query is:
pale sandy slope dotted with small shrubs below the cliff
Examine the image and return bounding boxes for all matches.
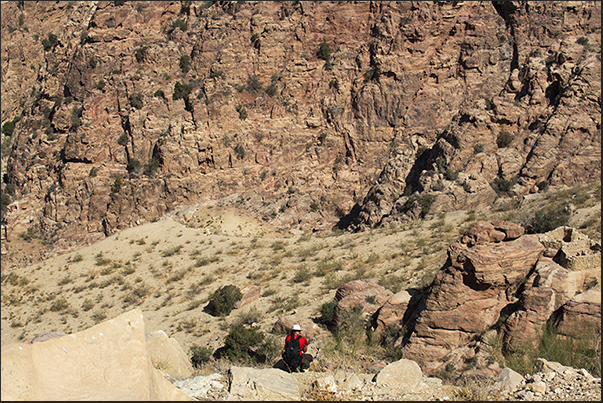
[1,194,601,374]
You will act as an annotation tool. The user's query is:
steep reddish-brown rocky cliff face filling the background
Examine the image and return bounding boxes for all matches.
[1,1,601,258]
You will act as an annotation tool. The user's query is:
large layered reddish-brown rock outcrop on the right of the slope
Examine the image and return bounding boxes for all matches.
[398,222,601,373]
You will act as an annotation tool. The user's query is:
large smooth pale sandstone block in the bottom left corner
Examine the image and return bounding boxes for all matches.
[1,310,189,401]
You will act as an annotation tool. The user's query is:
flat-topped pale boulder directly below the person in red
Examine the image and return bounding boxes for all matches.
[228,366,301,401]
